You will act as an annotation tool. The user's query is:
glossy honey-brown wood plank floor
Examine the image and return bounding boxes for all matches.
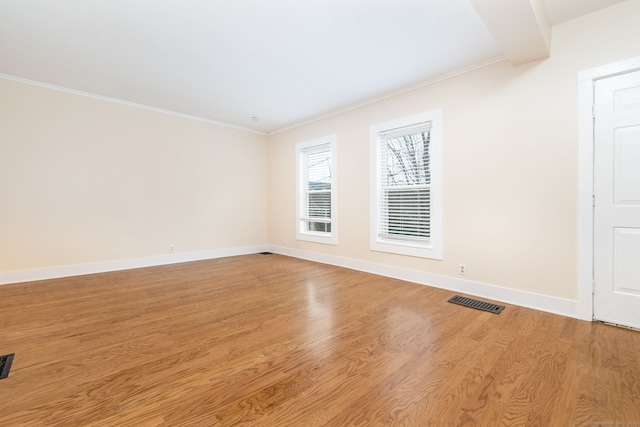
[0,254,640,427]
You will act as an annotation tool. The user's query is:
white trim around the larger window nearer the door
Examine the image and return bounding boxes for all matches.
[369,109,443,260]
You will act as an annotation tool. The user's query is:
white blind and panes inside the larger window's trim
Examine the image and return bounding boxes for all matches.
[377,122,431,243]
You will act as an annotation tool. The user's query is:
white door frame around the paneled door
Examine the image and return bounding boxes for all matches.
[577,57,640,320]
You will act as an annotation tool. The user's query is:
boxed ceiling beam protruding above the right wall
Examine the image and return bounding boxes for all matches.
[470,0,551,65]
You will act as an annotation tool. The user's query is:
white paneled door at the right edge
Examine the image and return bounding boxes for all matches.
[593,71,640,328]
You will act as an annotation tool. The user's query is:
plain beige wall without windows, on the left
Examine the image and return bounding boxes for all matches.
[0,79,267,272]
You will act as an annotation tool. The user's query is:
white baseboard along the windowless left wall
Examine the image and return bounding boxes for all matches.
[0,246,267,285]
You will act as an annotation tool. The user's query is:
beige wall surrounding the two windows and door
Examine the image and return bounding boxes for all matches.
[269,1,640,299]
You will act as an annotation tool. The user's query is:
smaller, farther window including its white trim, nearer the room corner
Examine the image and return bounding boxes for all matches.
[296,135,337,245]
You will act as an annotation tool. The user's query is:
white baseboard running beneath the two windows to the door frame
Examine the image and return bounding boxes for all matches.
[269,246,580,318]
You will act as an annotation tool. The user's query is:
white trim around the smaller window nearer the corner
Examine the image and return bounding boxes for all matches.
[296,135,338,245]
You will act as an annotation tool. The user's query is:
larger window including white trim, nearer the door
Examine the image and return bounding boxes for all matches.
[371,110,442,259]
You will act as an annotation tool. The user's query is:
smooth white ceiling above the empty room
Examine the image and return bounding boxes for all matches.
[0,0,621,133]
